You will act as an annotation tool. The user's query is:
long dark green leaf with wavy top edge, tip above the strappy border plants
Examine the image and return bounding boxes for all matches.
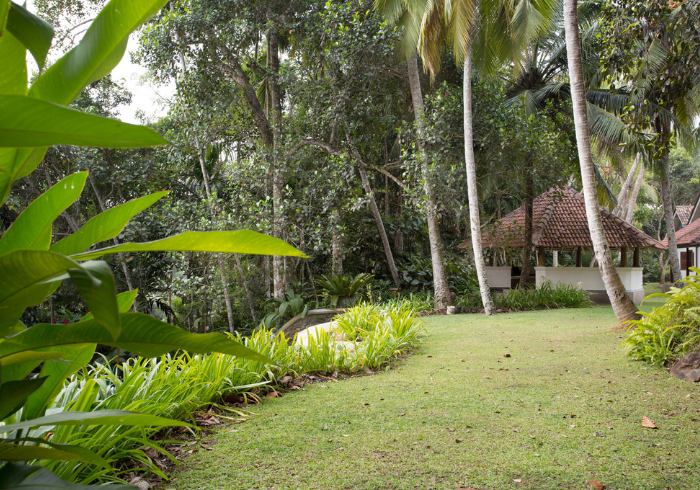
[0,313,272,363]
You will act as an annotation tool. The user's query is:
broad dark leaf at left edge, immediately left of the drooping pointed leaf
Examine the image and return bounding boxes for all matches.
[0,250,80,338]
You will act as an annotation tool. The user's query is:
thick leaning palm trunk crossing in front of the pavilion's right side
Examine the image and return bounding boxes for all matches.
[564,0,639,325]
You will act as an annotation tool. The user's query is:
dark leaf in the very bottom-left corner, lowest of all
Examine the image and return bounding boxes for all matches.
[0,463,138,490]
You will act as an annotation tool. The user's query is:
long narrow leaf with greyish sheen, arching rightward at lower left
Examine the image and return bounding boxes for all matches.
[0,410,192,434]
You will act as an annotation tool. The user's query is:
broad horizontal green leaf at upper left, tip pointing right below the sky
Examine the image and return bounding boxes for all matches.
[0,95,167,148]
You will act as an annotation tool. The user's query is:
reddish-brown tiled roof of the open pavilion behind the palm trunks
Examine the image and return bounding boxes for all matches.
[474,186,664,250]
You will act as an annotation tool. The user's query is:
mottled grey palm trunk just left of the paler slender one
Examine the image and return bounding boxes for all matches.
[408,55,452,310]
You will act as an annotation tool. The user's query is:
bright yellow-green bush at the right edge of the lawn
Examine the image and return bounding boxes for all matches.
[622,267,700,366]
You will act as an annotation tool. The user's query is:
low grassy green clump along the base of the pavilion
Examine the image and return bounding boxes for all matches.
[457,281,593,311]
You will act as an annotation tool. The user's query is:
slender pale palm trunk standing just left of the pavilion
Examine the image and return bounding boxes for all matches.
[462,39,495,315]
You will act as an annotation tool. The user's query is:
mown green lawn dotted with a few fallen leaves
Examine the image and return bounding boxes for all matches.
[166,305,700,490]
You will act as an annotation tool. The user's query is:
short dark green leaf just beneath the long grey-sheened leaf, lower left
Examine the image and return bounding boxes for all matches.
[0,437,110,468]
